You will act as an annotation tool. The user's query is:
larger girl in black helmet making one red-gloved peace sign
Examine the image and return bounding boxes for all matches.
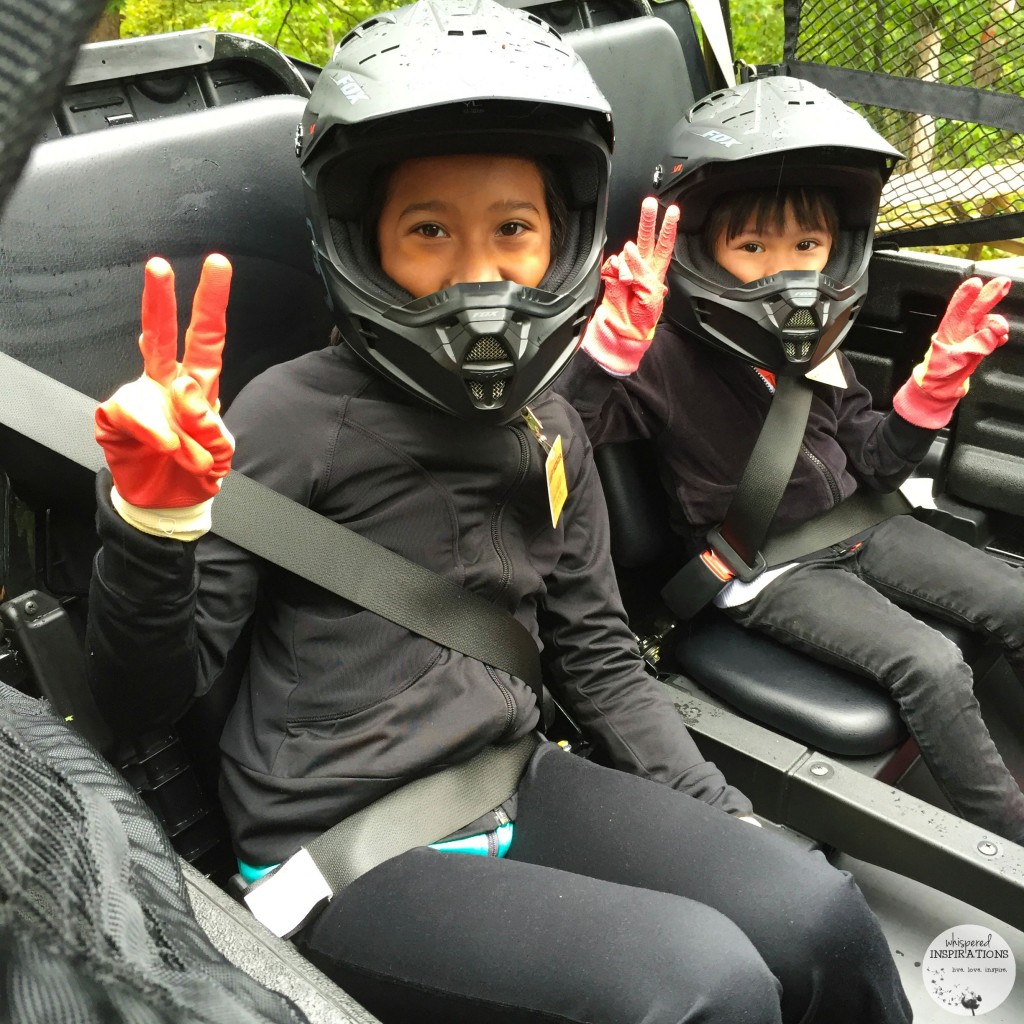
[89,9,909,1024]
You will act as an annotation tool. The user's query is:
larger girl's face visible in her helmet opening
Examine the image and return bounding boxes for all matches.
[377,154,551,298]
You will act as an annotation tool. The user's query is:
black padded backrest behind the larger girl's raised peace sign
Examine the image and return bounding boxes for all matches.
[0,96,330,400]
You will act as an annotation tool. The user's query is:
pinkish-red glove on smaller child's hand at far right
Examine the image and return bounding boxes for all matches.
[893,278,1010,430]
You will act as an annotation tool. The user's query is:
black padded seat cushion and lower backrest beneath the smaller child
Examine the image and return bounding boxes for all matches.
[596,441,980,757]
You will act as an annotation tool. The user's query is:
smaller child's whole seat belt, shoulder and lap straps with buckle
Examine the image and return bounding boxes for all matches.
[662,377,910,621]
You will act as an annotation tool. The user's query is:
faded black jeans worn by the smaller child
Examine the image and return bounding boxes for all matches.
[729,515,1024,844]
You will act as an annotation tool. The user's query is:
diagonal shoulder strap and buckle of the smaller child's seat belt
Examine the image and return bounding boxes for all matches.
[662,377,814,621]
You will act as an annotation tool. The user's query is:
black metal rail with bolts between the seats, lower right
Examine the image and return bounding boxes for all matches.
[663,676,1024,928]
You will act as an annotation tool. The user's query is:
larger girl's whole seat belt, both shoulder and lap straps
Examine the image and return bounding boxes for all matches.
[0,352,546,921]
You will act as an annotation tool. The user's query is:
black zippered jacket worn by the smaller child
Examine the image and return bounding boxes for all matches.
[556,321,936,545]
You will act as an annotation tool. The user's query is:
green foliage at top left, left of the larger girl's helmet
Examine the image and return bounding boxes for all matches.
[117,0,400,65]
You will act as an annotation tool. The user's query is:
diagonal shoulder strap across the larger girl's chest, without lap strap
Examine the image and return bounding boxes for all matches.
[0,352,544,709]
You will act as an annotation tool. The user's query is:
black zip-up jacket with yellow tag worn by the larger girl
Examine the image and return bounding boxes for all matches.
[89,346,750,864]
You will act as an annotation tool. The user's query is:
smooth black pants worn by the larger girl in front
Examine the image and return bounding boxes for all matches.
[298,744,911,1024]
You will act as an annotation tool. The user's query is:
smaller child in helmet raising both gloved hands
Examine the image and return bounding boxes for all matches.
[560,78,1024,842]
